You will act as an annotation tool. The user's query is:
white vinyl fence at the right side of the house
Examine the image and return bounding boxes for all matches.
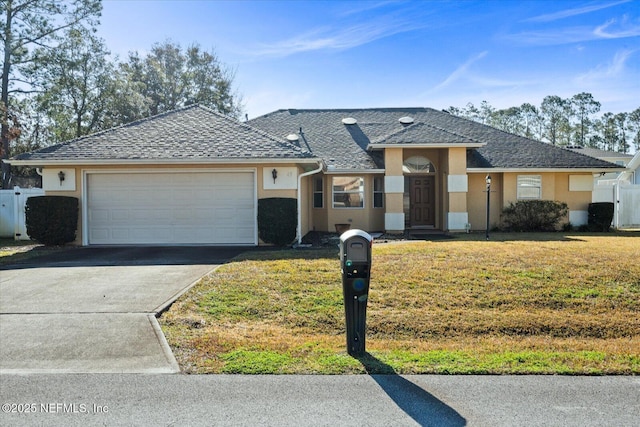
[592,183,640,229]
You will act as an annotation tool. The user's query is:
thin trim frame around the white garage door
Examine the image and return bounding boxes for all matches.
[82,168,258,246]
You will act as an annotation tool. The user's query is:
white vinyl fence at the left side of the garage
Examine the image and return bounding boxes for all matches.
[0,187,44,240]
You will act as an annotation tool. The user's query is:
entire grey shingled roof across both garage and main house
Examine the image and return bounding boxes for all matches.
[14,105,619,171]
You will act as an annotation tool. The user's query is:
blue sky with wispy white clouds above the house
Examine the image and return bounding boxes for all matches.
[98,0,640,117]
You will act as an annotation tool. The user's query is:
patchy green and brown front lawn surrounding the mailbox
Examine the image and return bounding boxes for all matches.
[160,233,640,375]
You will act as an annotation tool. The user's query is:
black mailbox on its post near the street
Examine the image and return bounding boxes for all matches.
[340,230,373,356]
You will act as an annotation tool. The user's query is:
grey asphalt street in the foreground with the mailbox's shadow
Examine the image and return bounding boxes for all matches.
[0,374,640,427]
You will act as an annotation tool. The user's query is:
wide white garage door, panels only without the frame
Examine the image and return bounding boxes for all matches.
[86,172,257,245]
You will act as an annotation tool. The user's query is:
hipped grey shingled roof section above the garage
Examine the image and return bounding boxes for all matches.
[15,105,314,162]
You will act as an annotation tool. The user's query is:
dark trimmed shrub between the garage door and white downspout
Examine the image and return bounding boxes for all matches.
[258,197,298,246]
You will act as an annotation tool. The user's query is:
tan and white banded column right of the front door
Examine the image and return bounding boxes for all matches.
[447,147,469,231]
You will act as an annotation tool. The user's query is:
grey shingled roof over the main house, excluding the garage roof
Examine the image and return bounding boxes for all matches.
[248,108,619,170]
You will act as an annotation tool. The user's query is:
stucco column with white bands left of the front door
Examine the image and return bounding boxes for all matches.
[384,148,404,233]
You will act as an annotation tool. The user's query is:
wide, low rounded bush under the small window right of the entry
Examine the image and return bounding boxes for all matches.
[502,200,569,231]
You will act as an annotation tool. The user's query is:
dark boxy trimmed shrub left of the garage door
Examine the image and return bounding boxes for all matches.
[25,196,78,246]
